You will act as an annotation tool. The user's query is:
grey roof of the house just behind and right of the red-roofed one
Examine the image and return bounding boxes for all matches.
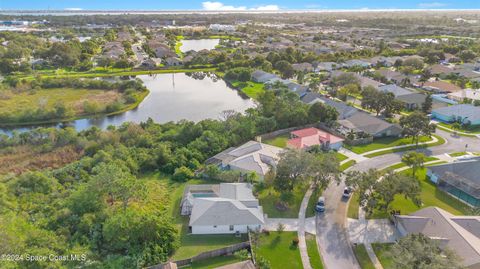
[338,111,401,136]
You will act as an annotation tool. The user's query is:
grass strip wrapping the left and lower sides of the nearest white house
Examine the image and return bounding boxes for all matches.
[138,173,244,260]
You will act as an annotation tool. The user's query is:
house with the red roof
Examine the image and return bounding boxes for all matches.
[287,127,344,150]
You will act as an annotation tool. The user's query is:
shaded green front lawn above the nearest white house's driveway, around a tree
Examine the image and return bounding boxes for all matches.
[258,186,307,218]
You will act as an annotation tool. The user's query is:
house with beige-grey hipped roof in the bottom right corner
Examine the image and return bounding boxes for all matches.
[394,207,480,269]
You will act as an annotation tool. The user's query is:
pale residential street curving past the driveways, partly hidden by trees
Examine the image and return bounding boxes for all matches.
[317,130,480,269]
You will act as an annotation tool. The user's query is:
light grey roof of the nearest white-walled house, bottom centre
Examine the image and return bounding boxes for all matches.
[189,197,265,226]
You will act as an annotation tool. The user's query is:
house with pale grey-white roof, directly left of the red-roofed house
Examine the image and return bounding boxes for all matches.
[206,141,283,178]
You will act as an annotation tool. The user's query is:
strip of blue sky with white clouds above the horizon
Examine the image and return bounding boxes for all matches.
[0,0,480,10]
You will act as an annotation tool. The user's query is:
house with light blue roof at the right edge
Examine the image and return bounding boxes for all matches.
[432,104,480,126]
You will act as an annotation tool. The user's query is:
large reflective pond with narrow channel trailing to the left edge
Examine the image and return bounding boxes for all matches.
[0,73,255,134]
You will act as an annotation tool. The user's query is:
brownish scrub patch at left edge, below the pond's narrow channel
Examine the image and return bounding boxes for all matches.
[0,146,83,174]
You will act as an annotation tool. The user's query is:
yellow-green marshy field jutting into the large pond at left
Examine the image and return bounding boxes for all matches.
[0,78,148,126]
